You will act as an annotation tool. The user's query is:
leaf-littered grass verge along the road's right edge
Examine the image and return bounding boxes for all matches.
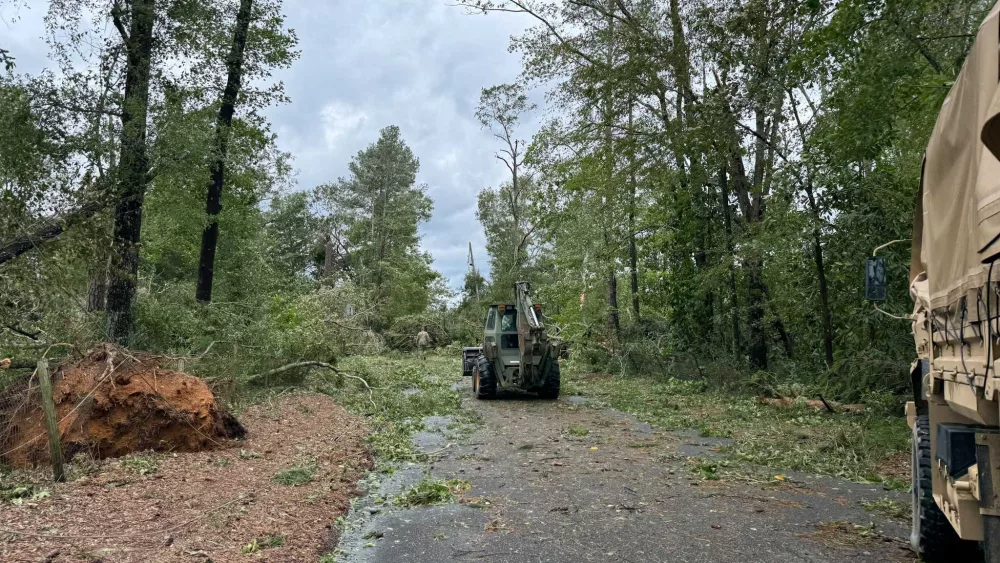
[563,370,910,487]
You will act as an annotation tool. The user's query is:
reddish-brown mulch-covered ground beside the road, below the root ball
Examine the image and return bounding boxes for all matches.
[0,394,371,563]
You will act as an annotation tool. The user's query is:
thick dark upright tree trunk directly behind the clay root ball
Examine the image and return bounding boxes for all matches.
[106,0,156,346]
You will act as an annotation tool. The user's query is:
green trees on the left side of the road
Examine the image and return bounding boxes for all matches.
[0,0,449,390]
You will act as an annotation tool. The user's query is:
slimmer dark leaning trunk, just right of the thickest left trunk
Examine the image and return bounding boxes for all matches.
[195,0,253,303]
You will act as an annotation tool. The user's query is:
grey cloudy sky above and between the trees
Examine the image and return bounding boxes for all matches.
[0,0,534,287]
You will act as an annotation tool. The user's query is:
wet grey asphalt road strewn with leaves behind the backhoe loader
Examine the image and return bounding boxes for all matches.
[338,381,915,563]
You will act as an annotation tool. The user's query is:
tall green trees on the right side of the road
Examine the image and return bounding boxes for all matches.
[460,0,994,399]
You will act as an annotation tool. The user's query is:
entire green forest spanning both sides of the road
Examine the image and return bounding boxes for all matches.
[0,0,992,406]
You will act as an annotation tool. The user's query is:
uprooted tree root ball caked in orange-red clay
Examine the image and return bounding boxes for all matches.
[0,345,245,468]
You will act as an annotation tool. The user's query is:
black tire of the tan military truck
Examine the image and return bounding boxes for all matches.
[910,415,979,563]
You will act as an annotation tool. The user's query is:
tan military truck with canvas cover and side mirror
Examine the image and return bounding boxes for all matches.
[896,3,1000,563]
